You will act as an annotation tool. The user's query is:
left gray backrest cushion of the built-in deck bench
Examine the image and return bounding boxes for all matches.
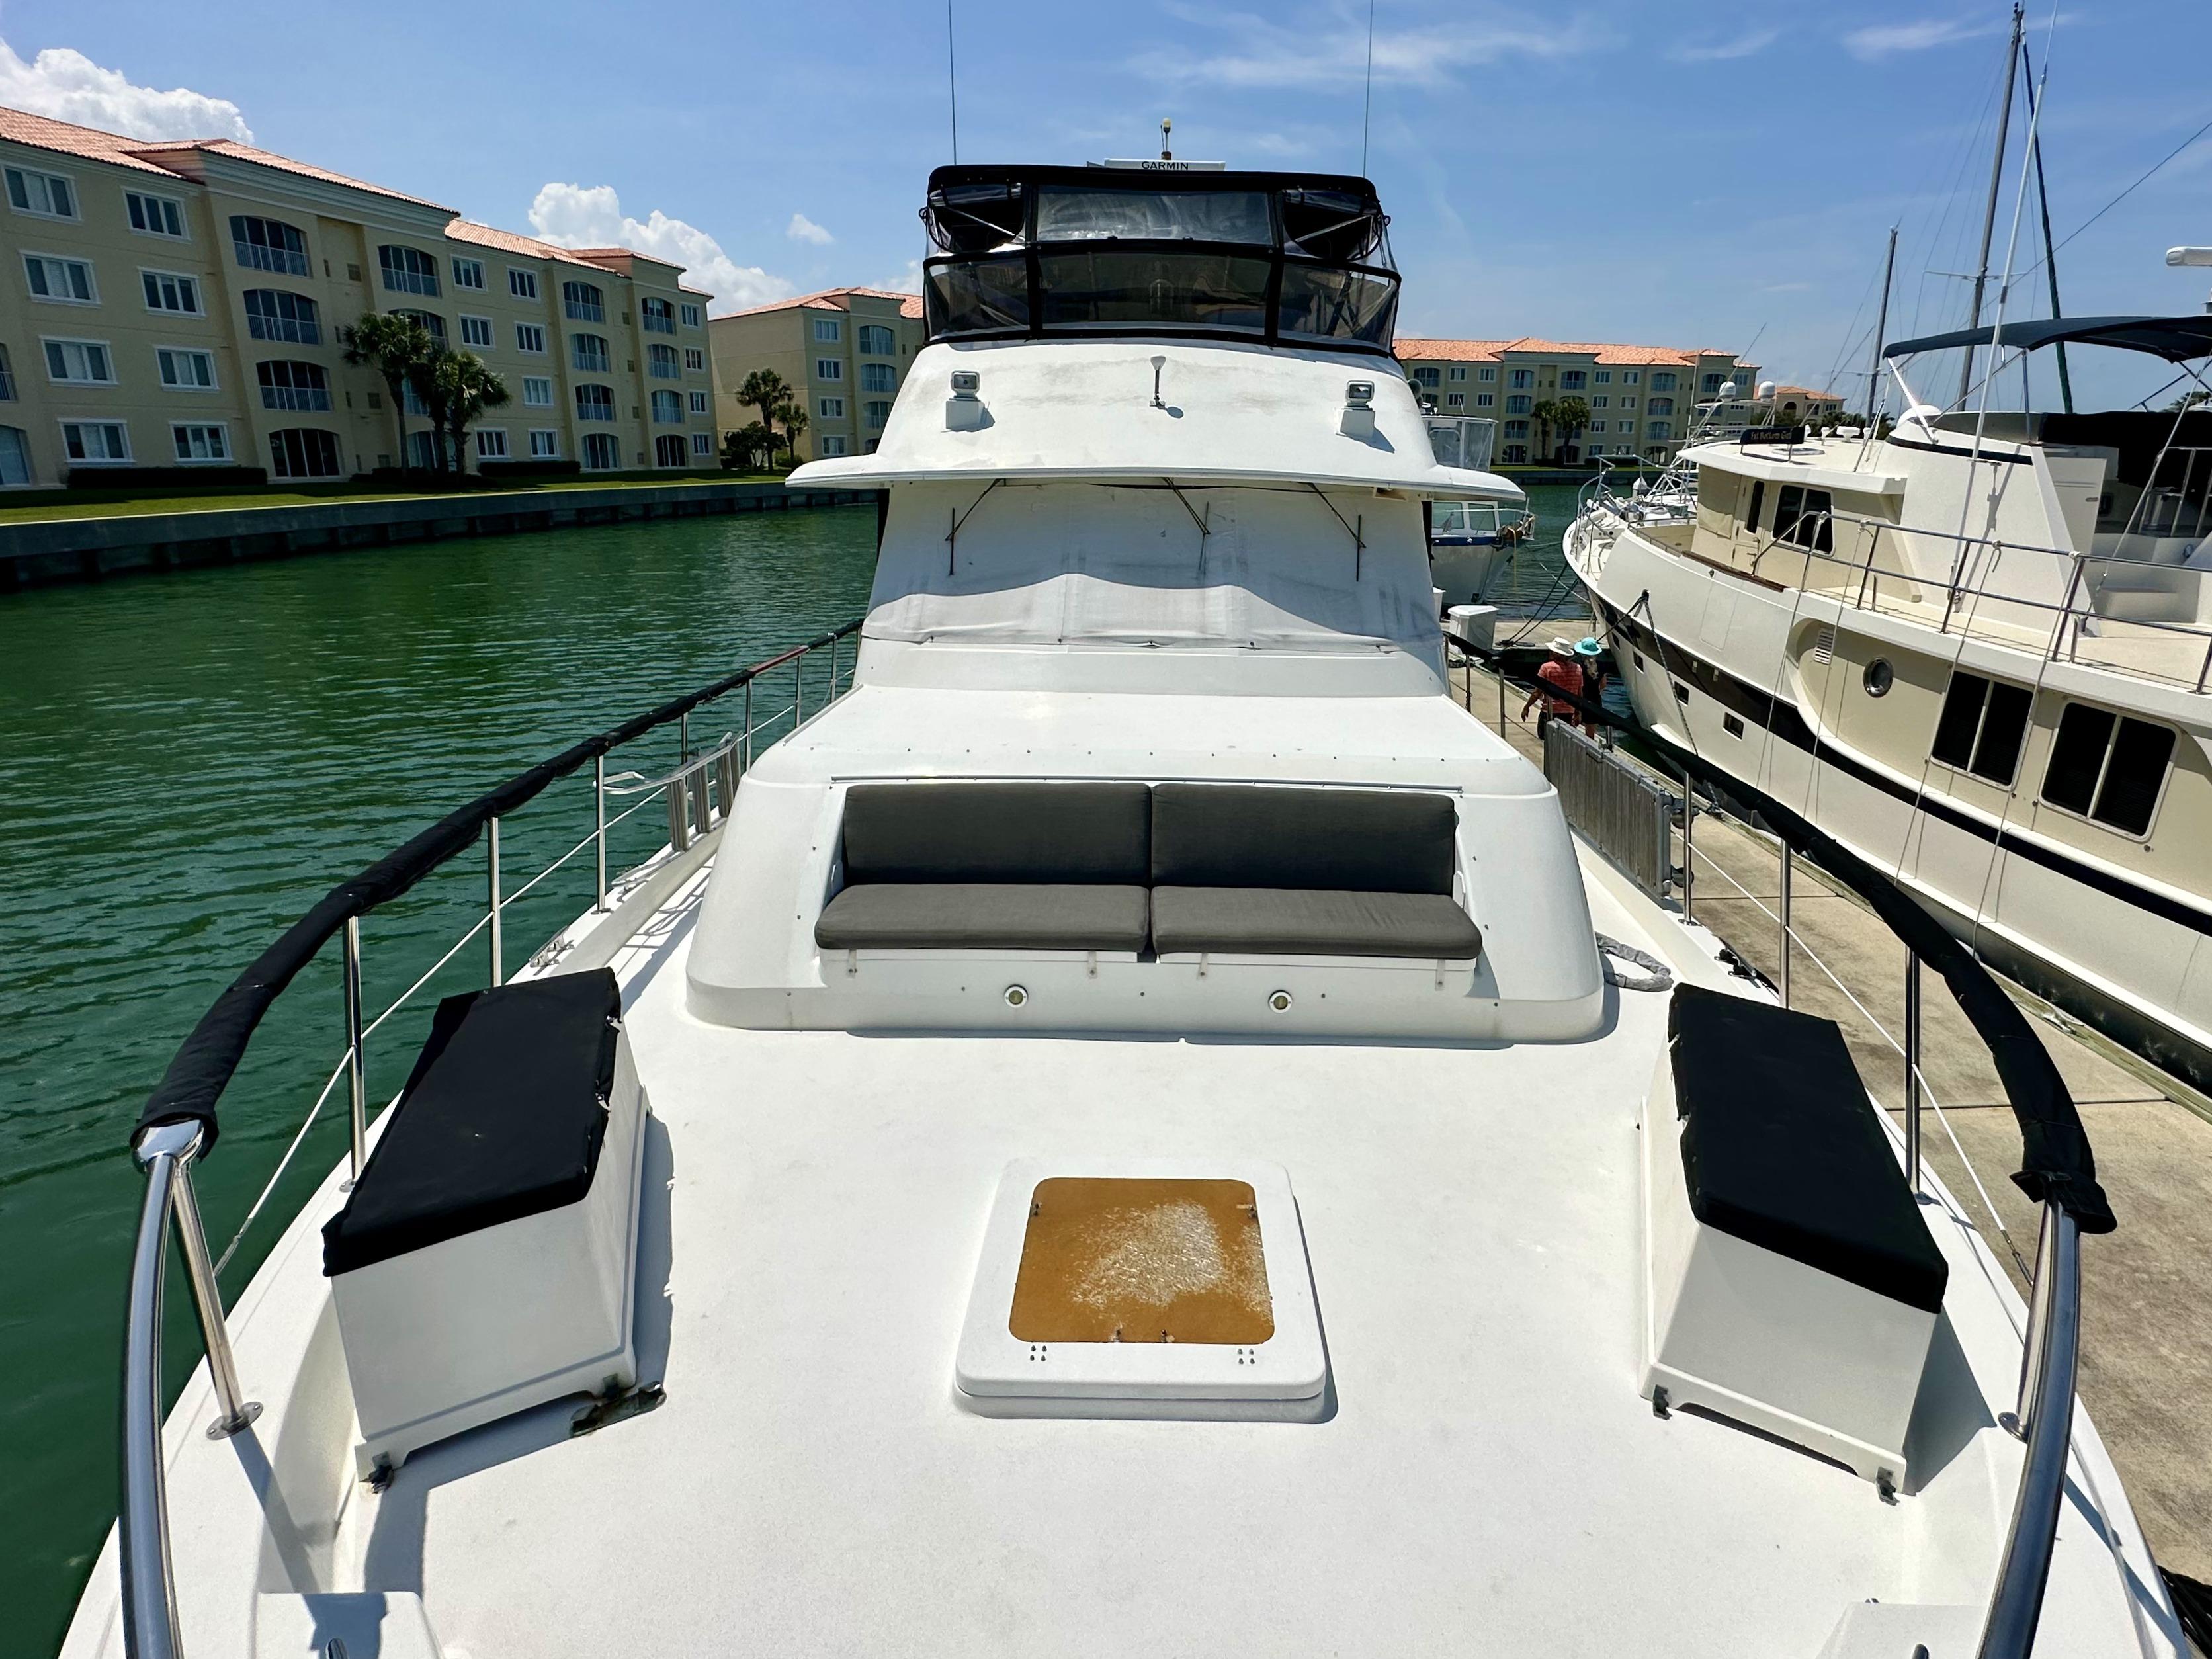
[845,783,1152,887]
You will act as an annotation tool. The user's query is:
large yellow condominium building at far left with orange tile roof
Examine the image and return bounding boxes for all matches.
[0,108,714,487]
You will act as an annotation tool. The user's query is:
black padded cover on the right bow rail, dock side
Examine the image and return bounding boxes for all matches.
[1460,650,2119,1232]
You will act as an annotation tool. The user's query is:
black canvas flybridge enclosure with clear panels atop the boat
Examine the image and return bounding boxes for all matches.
[922,166,1398,354]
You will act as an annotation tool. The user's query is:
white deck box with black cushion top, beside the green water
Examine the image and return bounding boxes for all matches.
[323,969,646,1473]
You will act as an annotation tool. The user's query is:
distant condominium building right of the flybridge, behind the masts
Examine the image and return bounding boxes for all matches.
[1398,339,1758,464]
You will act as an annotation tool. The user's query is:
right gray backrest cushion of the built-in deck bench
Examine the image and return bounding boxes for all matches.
[1152,783,1455,898]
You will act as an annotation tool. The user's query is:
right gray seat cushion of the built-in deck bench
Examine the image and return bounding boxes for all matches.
[1152,887,1482,962]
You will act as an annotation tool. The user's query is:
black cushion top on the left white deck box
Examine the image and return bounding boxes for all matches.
[323,969,622,1274]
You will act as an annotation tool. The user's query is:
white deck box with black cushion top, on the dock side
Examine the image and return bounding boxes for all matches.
[1644,986,1949,1486]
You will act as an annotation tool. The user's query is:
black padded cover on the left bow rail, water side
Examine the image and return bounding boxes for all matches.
[130,622,861,1157]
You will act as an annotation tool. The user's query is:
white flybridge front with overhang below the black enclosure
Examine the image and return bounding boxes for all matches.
[790,339,1524,502]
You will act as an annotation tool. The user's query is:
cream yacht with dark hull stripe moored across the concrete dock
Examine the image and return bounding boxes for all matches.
[1566,314,2212,1088]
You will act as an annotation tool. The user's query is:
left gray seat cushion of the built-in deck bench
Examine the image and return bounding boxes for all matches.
[814,880,1148,951]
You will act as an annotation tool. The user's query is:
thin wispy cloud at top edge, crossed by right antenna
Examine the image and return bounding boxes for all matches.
[1134,5,1606,89]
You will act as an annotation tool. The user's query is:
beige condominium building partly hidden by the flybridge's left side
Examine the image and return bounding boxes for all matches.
[708,288,922,460]
